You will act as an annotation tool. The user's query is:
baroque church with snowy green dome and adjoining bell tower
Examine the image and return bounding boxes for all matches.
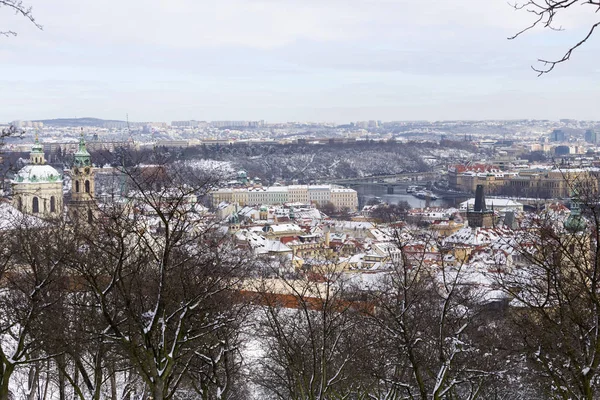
[11,133,94,221]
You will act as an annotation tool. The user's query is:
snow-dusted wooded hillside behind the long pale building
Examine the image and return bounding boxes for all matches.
[94,141,477,184]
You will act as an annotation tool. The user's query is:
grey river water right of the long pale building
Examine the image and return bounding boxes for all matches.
[352,183,466,209]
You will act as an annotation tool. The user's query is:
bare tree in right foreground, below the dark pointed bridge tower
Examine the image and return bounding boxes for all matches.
[364,236,502,400]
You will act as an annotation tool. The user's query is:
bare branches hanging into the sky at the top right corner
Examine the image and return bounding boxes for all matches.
[509,0,600,76]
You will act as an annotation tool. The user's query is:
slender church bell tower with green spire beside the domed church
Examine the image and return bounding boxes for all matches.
[70,131,94,222]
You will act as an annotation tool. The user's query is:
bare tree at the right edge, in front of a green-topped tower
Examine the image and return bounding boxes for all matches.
[501,186,600,399]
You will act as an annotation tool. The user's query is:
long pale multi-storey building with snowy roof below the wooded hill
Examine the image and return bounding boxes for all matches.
[211,185,358,211]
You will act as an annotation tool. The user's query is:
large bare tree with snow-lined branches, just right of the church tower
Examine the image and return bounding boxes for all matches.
[67,160,247,400]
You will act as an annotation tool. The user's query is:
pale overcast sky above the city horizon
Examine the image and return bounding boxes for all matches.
[0,0,600,122]
